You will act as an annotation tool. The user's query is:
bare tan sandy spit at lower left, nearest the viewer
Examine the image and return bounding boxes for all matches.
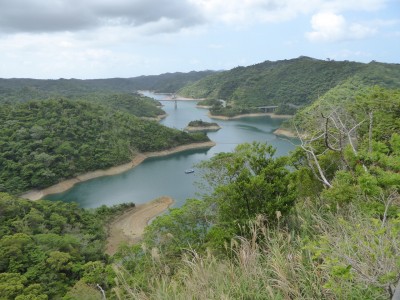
[106,196,174,255]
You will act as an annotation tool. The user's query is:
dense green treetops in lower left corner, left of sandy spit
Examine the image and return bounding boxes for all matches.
[0,193,134,300]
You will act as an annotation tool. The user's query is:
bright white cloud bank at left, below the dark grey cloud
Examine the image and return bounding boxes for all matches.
[0,33,145,78]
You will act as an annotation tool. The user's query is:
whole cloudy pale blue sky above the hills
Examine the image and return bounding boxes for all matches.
[0,0,400,79]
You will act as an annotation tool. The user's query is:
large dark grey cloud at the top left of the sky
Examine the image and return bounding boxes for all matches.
[0,0,204,33]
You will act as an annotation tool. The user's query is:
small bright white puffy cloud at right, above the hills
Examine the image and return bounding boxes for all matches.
[306,12,377,42]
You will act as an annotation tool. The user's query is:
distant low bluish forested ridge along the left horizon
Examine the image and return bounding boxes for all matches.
[0,71,214,102]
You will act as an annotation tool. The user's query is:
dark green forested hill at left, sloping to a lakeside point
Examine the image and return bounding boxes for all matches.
[0,99,208,193]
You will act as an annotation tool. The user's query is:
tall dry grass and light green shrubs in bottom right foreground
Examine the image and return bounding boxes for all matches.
[111,198,400,300]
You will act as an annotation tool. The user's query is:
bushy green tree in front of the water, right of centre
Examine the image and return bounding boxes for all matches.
[199,142,295,234]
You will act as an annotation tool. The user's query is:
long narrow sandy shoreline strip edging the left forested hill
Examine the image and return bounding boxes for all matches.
[19,141,215,201]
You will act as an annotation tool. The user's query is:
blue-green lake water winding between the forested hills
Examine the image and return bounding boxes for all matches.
[45,93,294,208]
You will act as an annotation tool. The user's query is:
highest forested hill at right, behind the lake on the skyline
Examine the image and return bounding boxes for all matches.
[178,57,400,112]
